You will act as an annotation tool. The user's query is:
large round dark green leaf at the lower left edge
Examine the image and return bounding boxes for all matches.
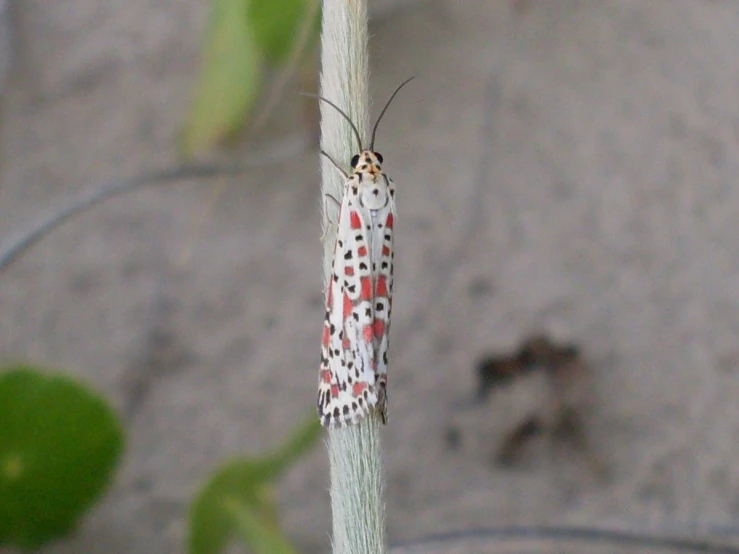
[0,366,123,549]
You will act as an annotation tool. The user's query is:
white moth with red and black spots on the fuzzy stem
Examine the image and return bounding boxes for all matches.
[310,78,412,427]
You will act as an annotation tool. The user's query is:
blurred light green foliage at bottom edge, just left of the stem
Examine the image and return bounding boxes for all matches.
[189,415,321,554]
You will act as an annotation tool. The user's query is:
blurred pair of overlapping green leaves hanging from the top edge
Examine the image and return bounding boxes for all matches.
[181,0,319,156]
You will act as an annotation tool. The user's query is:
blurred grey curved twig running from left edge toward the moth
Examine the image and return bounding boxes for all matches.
[0,136,310,272]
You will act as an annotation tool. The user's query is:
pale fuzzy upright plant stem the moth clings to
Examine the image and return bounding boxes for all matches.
[321,0,386,554]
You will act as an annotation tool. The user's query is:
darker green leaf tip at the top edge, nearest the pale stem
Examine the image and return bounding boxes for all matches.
[247,0,318,65]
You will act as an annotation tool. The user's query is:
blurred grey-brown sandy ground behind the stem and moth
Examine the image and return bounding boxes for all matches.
[0,0,739,554]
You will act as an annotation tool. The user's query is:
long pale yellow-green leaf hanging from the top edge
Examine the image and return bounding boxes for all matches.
[180,0,262,156]
